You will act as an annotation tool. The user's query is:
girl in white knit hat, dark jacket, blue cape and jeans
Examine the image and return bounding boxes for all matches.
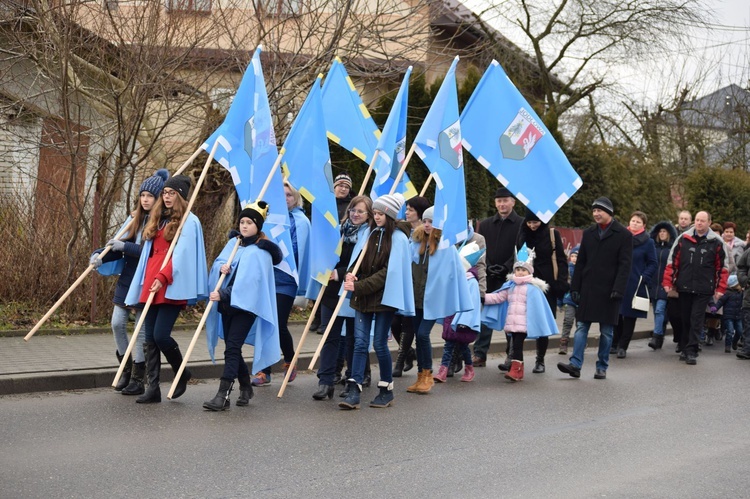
[339,193,414,409]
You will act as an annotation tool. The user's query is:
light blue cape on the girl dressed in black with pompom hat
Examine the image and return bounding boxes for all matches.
[206,239,281,374]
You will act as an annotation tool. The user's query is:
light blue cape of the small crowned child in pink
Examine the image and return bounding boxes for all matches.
[482,281,557,338]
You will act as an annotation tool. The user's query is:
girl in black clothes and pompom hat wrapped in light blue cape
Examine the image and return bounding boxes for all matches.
[203,201,283,411]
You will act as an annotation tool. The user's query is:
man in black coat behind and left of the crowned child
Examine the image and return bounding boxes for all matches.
[472,187,523,367]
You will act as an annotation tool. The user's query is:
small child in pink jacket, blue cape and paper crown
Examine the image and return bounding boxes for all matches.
[482,244,557,382]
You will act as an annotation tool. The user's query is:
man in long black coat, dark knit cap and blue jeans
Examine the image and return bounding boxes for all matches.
[557,197,633,379]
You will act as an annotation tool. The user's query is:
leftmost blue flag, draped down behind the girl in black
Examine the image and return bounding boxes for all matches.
[203,47,298,281]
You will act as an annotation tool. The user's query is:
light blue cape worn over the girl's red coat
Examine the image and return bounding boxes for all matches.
[125,213,208,305]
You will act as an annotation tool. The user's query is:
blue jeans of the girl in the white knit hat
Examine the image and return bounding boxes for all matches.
[352,310,396,385]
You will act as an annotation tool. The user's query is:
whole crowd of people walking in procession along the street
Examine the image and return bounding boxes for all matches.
[91,174,750,411]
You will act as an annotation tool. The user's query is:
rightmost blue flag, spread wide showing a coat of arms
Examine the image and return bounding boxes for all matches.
[461,61,583,223]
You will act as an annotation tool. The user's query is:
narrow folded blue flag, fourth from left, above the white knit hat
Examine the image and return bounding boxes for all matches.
[370,66,417,203]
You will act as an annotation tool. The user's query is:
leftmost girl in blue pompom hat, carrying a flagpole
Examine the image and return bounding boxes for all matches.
[90,169,169,395]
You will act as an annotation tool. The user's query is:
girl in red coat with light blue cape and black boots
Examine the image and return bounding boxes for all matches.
[125,175,208,404]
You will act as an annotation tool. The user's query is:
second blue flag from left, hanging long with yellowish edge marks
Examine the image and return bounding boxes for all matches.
[281,77,341,285]
